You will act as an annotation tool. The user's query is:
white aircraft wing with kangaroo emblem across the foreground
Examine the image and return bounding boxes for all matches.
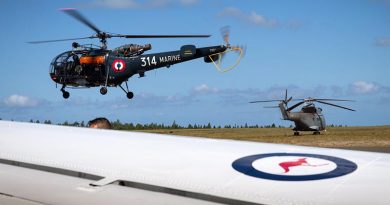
[0,121,390,205]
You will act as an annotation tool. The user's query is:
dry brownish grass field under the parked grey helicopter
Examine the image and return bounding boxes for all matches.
[144,125,390,153]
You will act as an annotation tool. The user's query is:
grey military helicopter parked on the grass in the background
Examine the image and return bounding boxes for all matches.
[250,90,355,135]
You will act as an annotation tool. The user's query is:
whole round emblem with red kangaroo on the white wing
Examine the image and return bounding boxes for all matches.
[232,153,357,181]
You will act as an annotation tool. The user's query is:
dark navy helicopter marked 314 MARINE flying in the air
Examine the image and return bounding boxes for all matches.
[28,8,243,99]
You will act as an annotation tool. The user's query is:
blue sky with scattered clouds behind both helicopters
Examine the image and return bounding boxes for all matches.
[0,0,390,125]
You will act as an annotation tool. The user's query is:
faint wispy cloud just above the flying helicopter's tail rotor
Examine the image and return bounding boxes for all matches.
[219,7,278,27]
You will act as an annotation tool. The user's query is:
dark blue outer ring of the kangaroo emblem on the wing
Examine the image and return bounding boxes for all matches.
[232,153,357,181]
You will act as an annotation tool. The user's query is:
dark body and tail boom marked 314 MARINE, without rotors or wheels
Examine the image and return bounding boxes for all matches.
[50,45,227,87]
